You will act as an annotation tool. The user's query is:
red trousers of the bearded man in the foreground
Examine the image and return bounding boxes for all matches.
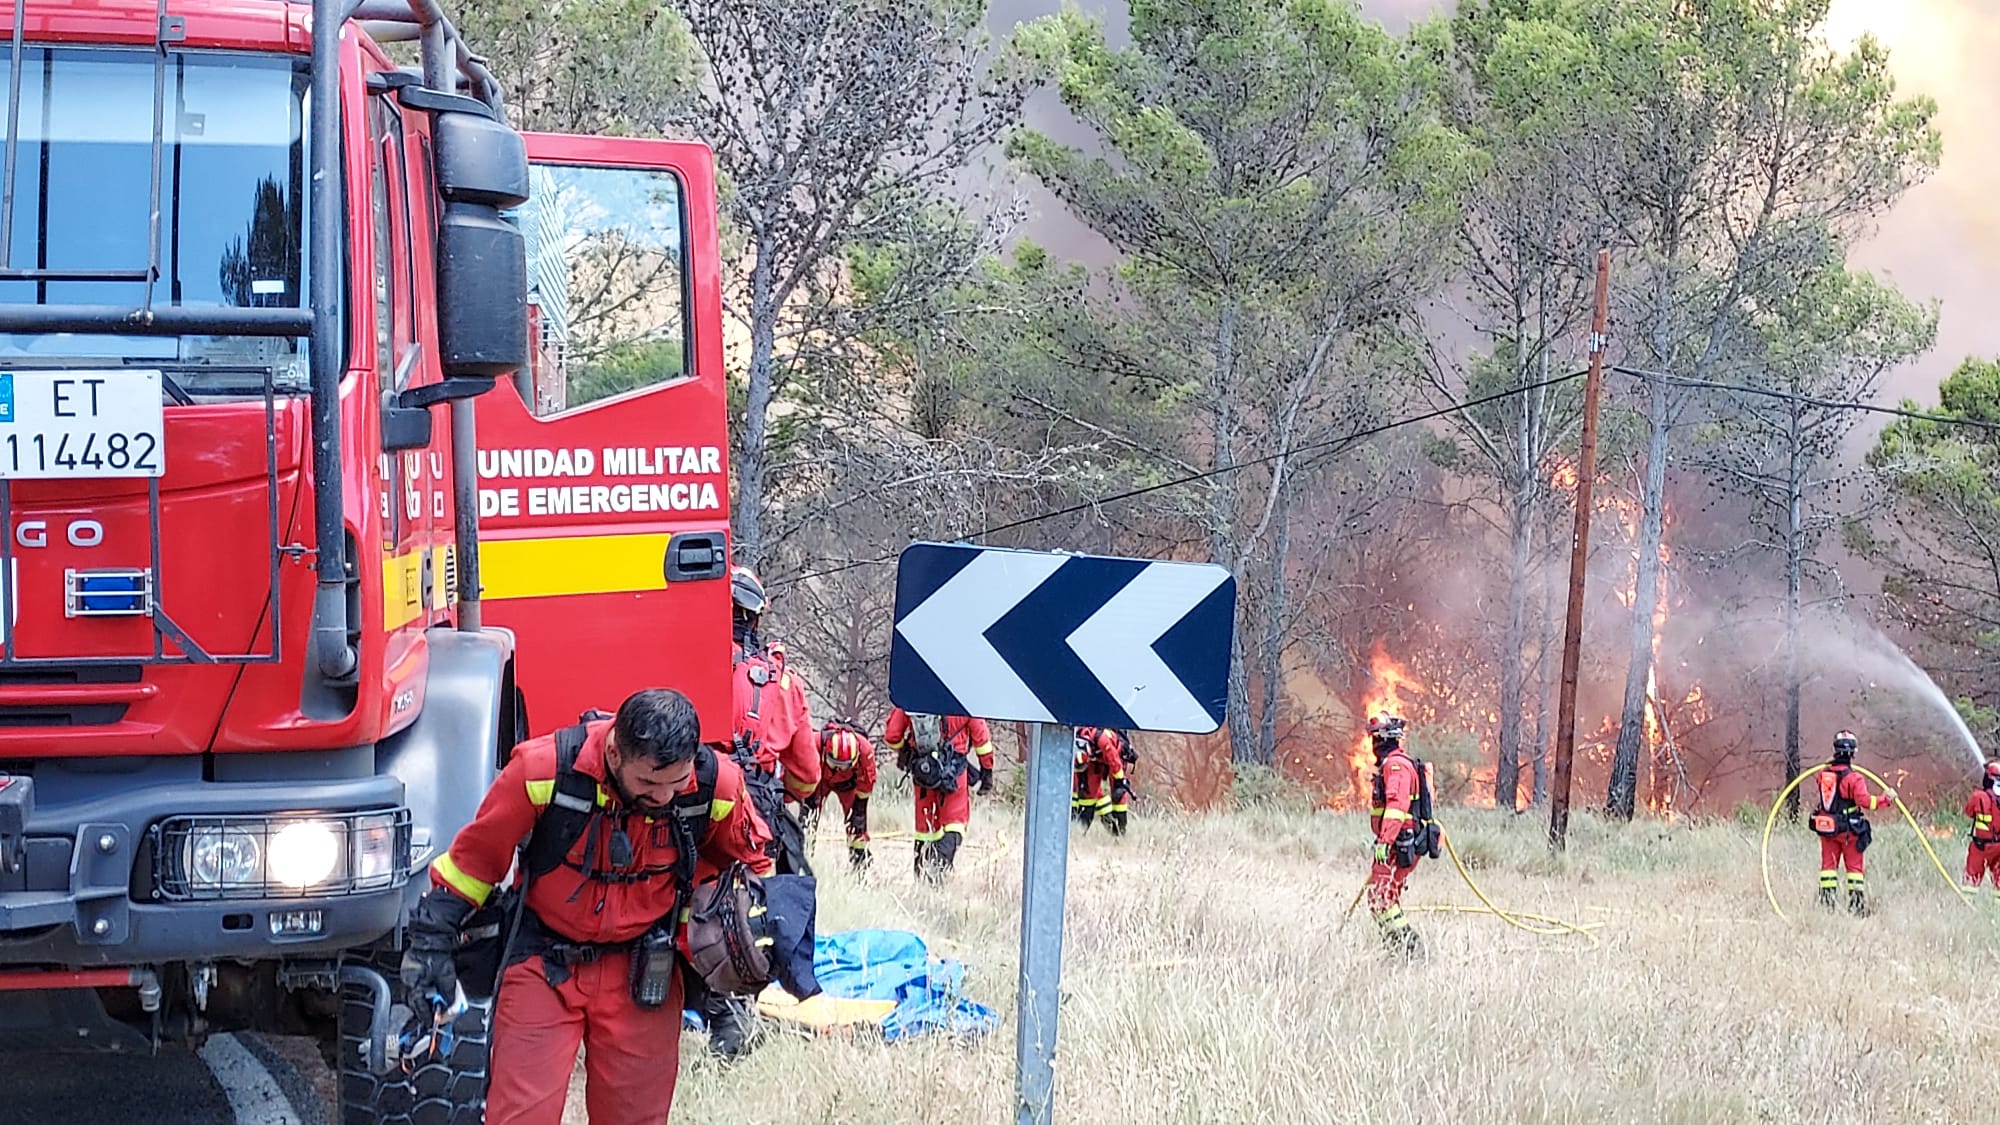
[486,953,682,1125]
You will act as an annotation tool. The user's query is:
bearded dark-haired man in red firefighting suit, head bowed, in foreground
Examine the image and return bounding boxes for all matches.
[402,689,772,1125]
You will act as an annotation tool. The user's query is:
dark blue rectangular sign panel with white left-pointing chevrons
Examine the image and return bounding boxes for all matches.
[888,542,1236,735]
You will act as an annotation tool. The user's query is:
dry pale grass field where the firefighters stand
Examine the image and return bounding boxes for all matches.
[570,795,2000,1125]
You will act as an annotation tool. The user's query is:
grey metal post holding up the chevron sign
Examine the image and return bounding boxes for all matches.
[1014,723,1070,1125]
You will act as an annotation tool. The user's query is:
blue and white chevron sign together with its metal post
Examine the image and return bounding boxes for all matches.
[888,542,1236,1125]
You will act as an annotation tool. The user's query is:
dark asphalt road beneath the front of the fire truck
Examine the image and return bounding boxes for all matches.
[0,1035,334,1125]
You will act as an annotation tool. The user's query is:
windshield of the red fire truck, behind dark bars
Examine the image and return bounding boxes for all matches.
[0,48,308,394]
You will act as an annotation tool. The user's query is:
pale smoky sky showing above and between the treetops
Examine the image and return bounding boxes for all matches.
[992,0,2000,400]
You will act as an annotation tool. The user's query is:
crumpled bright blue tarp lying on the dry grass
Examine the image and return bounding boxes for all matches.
[686,929,1000,1041]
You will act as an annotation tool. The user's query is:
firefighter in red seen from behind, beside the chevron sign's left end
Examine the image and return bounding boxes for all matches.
[882,707,994,883]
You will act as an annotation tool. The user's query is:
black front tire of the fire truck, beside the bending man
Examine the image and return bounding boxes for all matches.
[338,949,492,1125]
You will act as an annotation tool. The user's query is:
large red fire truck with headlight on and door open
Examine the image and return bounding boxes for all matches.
[0,0,728,1121]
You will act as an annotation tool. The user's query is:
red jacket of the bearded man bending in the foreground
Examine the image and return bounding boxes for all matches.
[430,719,772,943]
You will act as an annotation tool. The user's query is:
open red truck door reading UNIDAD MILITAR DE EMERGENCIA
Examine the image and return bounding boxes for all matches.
[476,134,730,743]
